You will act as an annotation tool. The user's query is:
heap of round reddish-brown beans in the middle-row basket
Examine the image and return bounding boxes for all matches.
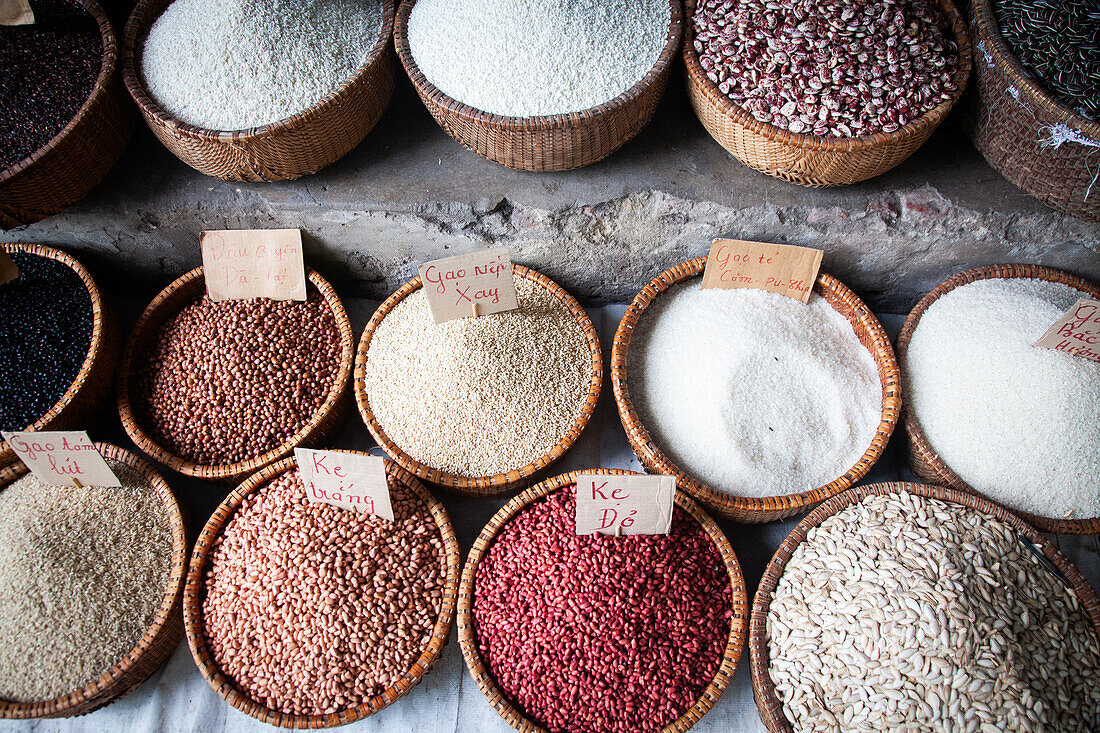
[135,286,341,464]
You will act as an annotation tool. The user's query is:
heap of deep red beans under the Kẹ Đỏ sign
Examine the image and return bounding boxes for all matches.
[473,486,733,731]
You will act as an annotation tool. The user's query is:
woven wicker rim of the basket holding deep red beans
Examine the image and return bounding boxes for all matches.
[458,469,749,733]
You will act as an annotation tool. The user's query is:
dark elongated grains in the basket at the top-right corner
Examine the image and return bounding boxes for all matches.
[993,0,1100,120]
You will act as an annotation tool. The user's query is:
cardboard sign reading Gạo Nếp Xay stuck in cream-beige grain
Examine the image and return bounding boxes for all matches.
[418,249,519,324]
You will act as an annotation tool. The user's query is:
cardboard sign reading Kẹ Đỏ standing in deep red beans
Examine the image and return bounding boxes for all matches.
[576,473,677,535]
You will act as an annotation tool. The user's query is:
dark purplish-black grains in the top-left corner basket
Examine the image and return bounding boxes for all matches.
[0,0,103,168]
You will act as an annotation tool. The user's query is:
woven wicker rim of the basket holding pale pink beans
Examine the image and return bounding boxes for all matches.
[184,451,462,729]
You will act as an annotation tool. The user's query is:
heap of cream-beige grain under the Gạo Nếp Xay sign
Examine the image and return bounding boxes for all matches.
[364,277,592,477]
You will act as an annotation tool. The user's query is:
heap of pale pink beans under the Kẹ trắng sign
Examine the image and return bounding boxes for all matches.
[202,471,447,715]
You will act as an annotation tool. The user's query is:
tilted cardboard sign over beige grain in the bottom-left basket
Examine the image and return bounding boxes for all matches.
[3,430,122,486]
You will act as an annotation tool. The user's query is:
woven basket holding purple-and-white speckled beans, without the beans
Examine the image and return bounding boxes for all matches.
[683,0,971,187]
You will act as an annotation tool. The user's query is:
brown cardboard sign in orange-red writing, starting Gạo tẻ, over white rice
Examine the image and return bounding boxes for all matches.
[703,239,824,303]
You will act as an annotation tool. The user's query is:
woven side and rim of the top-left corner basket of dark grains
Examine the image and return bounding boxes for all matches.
[0,0,134,229]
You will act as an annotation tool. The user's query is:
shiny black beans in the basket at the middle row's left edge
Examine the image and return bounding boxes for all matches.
[0,252,94,430]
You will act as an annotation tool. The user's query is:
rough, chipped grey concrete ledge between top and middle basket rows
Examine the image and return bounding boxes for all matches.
[0,77,1100,311]
